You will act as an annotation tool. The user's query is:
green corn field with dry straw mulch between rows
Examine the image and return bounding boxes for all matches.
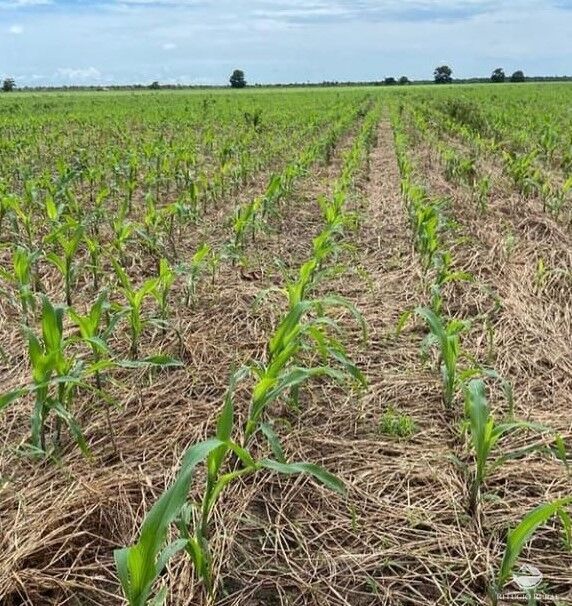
[0,84,572,606]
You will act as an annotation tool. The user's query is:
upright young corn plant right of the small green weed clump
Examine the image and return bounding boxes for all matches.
[464,379,547,515]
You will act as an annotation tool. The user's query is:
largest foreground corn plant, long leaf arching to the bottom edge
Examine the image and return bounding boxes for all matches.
[115,371,344,606]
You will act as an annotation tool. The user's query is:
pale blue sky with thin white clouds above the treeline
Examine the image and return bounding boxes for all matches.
[0,0,572,86]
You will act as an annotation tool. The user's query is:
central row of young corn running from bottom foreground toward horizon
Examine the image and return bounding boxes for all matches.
[115,98,379,606]
